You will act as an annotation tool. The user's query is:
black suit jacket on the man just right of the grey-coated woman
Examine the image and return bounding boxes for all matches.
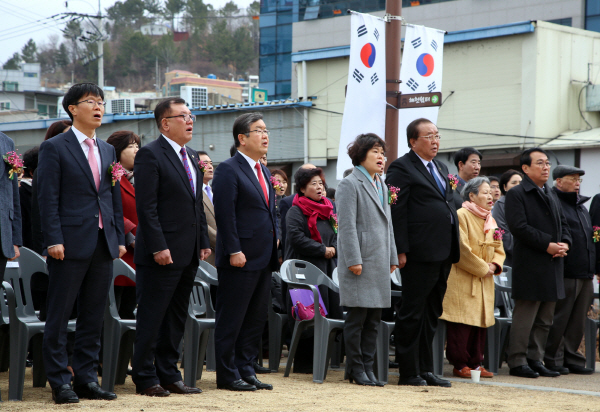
[386,150,460,263]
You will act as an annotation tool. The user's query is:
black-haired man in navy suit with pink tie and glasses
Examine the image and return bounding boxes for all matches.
[37,83,126,403]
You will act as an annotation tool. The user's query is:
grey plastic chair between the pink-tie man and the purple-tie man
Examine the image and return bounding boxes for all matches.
[102,259,136,392]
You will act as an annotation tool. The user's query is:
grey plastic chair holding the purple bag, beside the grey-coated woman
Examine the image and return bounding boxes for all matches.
[281,259,344,383]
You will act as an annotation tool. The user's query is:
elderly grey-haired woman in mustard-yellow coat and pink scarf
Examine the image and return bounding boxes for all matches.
[440,176,505,378]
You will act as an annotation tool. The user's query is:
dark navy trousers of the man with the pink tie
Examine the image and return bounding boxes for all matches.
[42,230,113,388]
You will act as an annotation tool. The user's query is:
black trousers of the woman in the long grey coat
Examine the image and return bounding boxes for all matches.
[344,307,381,373]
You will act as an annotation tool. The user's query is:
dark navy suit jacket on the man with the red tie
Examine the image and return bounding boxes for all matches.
[213,152,279,271]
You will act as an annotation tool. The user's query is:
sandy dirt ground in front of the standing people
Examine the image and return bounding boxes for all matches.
[0,359,600,412]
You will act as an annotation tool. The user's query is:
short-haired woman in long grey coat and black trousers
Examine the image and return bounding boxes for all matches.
[335,133,398,386]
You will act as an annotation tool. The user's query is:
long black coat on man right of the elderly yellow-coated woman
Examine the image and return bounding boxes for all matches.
[505,176,572,302]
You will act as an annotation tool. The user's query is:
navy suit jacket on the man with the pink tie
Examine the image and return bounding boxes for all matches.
[36,130,125,259]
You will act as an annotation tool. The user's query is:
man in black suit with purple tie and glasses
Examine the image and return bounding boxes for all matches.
[132,98,211,397]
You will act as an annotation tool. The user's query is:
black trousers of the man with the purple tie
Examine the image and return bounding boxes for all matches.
[131,256,198,392]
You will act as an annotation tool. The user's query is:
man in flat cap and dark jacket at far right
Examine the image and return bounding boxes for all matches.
[544,165,596,375]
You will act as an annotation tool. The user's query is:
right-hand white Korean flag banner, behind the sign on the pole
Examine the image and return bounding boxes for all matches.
[398,25,446,157]
